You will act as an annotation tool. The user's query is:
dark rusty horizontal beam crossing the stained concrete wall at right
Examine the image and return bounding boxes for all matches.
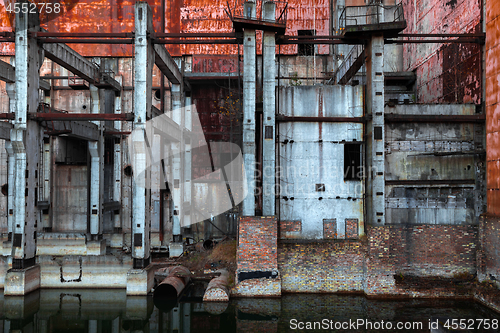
[385,113,486,123]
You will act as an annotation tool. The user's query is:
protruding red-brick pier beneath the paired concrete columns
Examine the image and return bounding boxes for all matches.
[237,216,278,271]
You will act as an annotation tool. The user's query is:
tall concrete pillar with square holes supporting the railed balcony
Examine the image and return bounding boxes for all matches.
[366,35,385,226]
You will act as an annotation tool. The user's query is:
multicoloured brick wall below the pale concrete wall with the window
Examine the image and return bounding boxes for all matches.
[278,241,365,292]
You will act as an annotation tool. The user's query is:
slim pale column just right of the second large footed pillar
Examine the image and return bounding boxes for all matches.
[169,84,185,257]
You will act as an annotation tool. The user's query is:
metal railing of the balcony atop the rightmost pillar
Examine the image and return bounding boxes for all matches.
[339,3,404,31]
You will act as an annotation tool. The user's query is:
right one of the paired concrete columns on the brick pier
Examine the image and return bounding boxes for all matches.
[262,1,276,216]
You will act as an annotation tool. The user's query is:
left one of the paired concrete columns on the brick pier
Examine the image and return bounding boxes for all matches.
[242,1,256,216]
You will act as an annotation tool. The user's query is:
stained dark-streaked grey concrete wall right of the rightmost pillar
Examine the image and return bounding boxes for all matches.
[385,104,485,224]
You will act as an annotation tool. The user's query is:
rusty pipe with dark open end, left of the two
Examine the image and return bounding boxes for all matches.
[153,266,191,300]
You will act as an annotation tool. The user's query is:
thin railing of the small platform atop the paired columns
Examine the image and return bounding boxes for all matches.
[225,0,288,25]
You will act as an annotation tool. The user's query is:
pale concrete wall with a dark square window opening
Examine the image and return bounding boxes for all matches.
[278,86,364,239]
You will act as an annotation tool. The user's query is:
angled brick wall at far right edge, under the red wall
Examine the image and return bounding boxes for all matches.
[477,215,500,288]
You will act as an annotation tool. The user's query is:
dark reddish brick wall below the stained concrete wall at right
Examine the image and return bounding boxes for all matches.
[364,225,478,295]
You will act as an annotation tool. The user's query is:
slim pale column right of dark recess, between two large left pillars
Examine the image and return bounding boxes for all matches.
[88,85,104,240]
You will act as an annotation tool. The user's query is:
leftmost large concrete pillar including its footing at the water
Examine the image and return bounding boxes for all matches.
[4,1,43,295]
